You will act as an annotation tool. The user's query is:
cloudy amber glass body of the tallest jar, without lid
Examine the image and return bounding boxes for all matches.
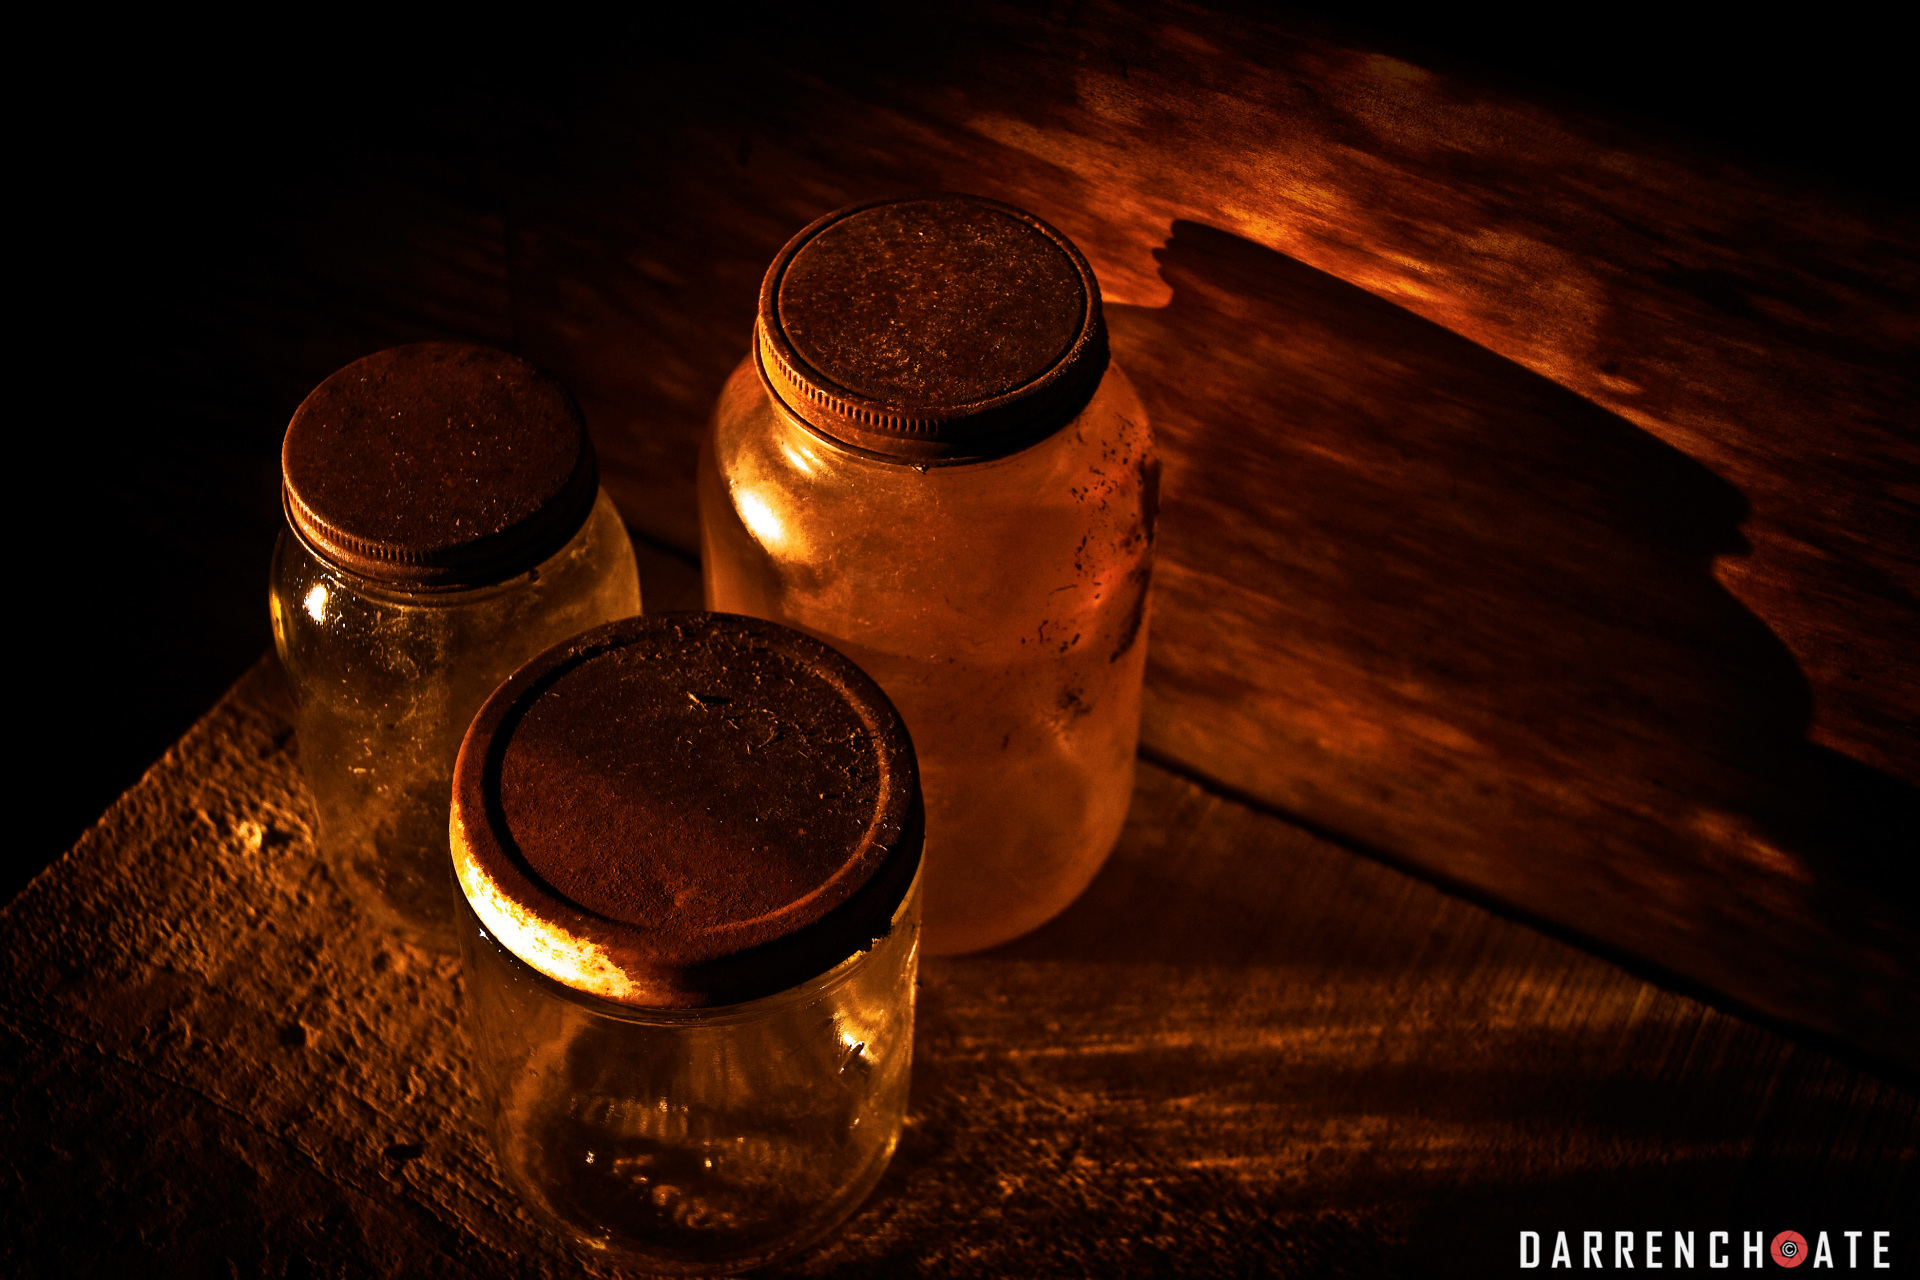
[699,355,1160,954]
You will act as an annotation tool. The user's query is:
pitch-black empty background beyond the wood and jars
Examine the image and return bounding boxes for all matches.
[18,4,1914,896]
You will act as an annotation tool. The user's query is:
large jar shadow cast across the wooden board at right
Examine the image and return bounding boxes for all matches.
[1110,223,1916,1065]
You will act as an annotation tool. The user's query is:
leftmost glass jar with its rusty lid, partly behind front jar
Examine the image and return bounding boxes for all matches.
[269,344,639,952]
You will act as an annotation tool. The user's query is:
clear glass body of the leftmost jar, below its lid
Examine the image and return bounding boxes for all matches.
[269,491,639,952]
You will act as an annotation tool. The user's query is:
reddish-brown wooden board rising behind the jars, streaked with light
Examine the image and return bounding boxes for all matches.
[476,4,1920,1067]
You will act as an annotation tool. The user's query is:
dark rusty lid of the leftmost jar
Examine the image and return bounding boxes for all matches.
[280,342,599,589]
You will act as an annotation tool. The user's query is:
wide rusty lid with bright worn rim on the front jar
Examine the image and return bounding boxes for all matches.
[451,614,924,1007]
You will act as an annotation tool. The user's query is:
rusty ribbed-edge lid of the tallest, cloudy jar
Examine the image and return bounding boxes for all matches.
[755,196,1108,464]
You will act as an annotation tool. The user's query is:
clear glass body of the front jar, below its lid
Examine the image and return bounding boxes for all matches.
[459,879,920,1274]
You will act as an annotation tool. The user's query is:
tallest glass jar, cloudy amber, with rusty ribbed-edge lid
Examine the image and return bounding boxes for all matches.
[699,196,1160,954]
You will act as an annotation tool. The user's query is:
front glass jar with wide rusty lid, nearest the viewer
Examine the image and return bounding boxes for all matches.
[451,614,922,1274]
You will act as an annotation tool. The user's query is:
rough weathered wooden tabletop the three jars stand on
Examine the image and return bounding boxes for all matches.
[0,640,1920,1276]
